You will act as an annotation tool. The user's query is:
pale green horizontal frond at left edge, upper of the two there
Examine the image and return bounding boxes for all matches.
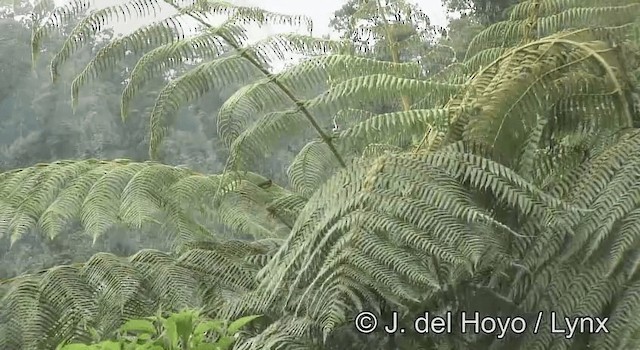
[0,160,296,244]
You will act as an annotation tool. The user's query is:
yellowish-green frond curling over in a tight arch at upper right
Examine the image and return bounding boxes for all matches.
[450,31,633,170]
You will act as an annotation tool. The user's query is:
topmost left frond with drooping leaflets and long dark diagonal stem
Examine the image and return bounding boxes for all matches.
[28,0,350,165]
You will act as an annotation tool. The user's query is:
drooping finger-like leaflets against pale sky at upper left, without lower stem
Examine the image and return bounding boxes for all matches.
[32,0,318,156]
